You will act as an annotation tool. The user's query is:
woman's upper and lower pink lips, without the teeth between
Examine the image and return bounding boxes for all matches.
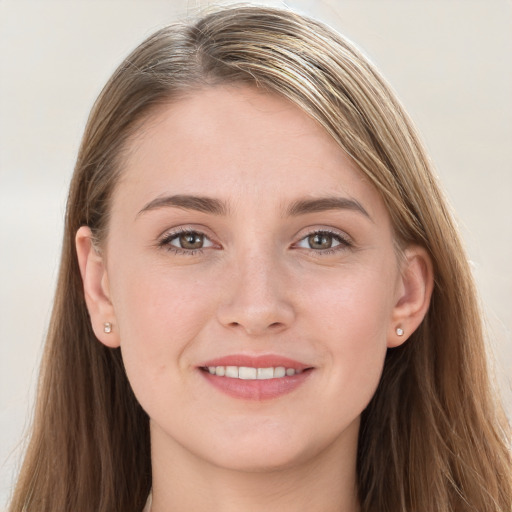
[198,354,313,401]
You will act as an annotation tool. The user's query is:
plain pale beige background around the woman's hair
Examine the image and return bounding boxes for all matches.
[0,0,512,510]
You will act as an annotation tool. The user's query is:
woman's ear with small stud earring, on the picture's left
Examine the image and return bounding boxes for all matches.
[75,226,120,348]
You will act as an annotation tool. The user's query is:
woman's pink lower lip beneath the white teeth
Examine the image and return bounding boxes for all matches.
[200,370,312,400]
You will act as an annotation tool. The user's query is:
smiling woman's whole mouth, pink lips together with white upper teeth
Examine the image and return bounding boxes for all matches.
[198,355,314,400]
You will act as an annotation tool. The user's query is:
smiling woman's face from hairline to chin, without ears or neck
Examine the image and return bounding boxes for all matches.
[90,86,403,469]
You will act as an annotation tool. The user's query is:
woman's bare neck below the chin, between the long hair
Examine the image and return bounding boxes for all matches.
[151,424,359,512]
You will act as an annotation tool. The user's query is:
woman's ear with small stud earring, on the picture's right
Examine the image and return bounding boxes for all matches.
[387,246,434,348]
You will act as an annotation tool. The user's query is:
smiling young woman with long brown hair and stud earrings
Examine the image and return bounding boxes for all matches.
[10,7,512,512]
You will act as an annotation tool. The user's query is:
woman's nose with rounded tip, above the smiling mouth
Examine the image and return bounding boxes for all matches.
[217,251,295,336]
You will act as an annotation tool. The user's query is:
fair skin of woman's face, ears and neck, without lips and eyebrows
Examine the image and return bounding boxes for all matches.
[77,86,432,512]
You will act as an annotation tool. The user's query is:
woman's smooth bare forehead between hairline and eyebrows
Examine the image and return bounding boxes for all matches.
[112,85,382,218]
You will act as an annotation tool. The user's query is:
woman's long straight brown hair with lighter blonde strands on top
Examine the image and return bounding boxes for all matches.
[10,7,512,512]
